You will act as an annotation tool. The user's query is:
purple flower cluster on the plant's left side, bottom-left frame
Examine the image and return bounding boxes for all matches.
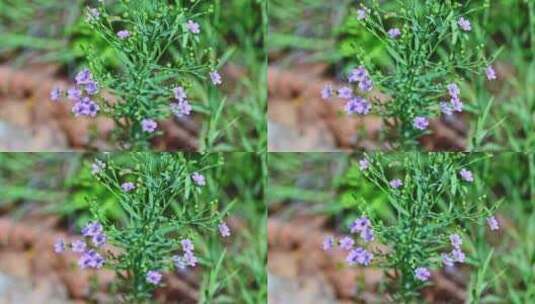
[54,222,107,269]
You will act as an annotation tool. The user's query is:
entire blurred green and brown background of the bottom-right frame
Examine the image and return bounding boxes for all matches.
[266,152,535,304]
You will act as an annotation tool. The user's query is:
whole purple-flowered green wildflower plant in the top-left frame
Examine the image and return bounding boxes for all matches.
[50,0,223,149]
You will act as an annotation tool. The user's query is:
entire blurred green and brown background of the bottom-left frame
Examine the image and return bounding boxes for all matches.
[0,153,267,304]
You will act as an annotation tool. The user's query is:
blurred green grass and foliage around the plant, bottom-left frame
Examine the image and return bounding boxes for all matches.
[0,152,267,304]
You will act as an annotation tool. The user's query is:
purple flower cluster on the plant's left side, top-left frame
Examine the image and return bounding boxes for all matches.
[50,69,100,117]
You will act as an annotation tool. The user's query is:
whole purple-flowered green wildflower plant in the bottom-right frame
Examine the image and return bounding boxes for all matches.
[322,153,499,303]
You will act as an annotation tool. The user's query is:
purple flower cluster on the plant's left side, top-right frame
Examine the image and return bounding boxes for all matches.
[321,66,373,115]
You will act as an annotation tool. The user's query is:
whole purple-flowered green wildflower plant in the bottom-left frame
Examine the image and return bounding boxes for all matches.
[54,153,231,303]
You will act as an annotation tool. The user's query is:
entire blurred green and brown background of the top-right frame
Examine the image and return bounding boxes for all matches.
[268,0,535,151]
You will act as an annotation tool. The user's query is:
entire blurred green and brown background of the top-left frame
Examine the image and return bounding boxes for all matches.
[0,0,267,151]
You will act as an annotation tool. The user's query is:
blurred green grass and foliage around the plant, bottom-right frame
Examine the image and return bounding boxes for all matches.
[267,152,535,304]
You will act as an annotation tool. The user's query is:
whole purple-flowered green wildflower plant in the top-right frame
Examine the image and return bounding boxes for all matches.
[321,0,502,148]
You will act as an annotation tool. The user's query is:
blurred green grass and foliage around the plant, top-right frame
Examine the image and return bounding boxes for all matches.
[268,0,535,151]
